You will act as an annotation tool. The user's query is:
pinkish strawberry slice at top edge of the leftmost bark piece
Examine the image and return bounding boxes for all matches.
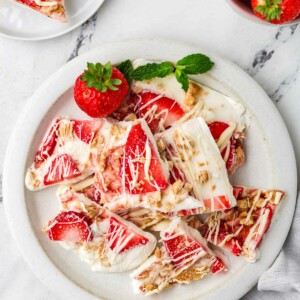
[73,120,101,144]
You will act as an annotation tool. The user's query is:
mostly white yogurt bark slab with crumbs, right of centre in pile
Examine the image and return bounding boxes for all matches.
[155,117,236,214]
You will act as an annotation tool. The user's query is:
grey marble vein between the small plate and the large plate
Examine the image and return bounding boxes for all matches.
[68,13,97,61]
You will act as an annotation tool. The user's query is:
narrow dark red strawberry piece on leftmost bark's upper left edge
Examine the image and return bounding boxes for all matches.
[34,119,60,168]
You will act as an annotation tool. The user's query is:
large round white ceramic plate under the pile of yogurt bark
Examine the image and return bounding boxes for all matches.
[3,40,297,300]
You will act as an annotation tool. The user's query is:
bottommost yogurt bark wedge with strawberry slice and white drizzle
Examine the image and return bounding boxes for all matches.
[131,217,226,295]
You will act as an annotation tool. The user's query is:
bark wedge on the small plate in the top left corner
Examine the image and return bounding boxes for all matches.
[13,0,67,22]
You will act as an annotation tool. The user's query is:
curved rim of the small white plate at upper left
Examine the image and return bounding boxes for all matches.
[0,0,105,42]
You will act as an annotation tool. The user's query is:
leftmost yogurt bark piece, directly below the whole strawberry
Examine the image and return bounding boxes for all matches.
[25,118,131,190]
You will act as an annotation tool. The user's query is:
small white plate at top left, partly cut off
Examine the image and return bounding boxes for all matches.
[0,0,104,41]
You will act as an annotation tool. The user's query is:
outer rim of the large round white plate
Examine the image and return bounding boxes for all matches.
[3,39,297,299]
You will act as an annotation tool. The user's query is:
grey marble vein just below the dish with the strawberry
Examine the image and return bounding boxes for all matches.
[247,24,298,76]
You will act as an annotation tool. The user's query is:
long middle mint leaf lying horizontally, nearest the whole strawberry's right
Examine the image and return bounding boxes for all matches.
[131,62,175,81]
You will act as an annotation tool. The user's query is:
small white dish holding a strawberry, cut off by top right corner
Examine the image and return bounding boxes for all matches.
[227,0,300,26]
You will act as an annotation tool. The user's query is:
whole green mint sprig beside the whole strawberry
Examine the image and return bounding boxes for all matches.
[117,53,214,92]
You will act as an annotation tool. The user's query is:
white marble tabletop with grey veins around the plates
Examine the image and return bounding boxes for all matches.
[0,0,300,300]
